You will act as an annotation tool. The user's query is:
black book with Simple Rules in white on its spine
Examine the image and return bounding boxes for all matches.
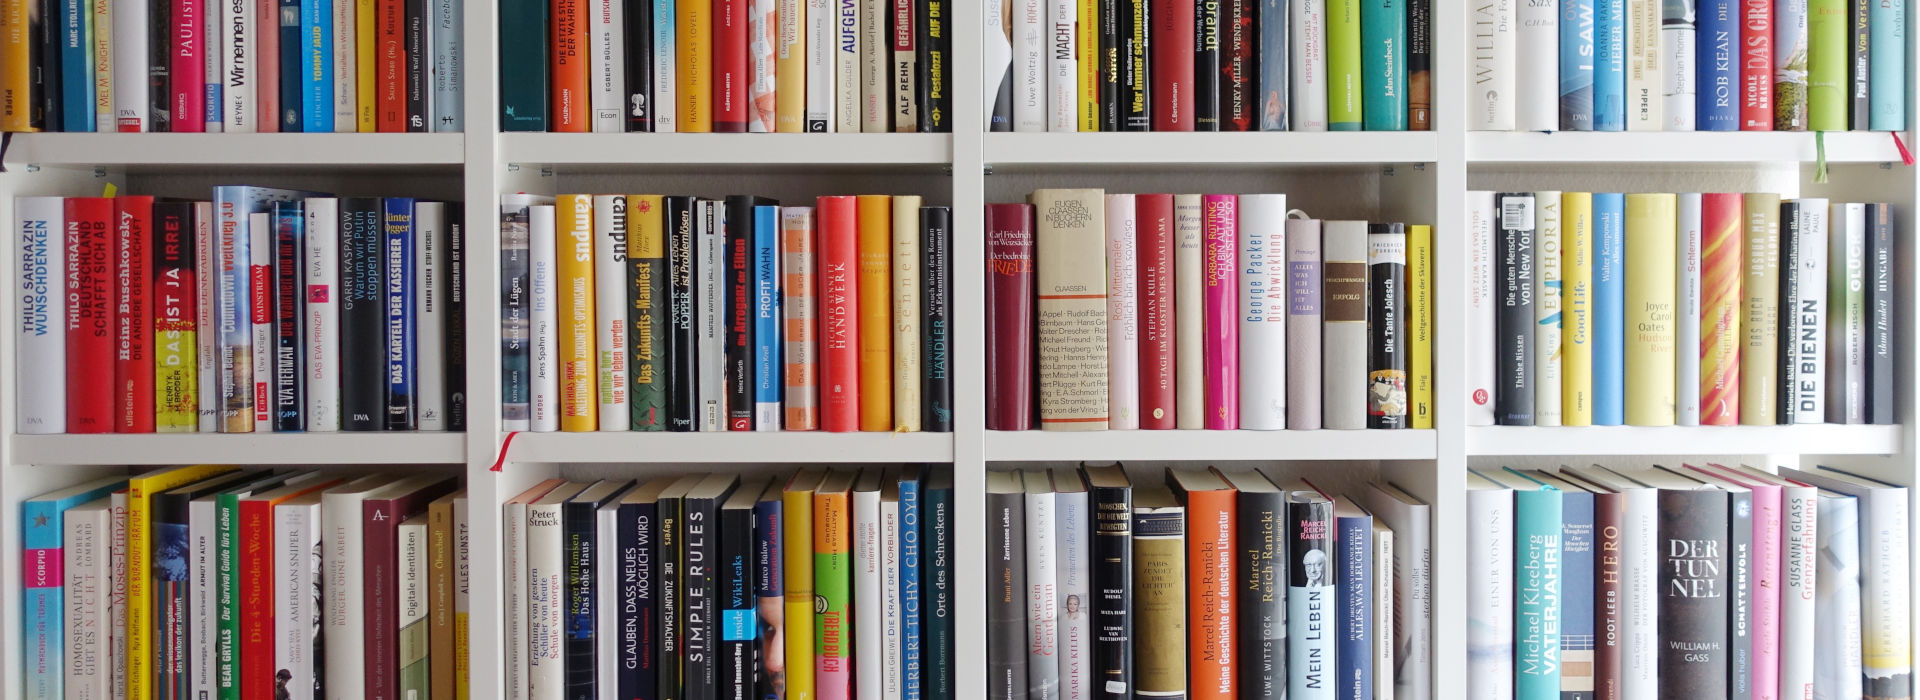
[680,474,739,700]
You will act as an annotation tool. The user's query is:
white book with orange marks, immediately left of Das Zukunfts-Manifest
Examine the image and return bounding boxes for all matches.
[593,194,632,432]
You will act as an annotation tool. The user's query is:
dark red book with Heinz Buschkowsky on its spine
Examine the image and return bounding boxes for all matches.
[113,196,154,433]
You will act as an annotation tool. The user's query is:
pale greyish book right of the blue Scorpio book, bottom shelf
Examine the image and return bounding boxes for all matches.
[60,497,112,700]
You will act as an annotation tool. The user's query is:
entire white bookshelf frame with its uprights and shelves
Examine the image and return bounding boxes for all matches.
[0,2,1920,700]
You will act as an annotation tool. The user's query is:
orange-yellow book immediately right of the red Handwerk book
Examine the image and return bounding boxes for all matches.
[856,194,893,432]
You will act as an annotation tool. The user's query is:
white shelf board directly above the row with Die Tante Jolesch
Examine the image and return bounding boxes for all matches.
[985,130,1440,167]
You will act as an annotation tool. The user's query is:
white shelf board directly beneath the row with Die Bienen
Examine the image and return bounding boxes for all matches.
[1467,426,1901,456]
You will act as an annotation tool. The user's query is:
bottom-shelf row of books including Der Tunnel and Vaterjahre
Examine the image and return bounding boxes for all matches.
[1465,464,1912,698]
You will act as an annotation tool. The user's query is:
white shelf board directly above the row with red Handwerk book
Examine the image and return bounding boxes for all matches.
[499,132,952,165]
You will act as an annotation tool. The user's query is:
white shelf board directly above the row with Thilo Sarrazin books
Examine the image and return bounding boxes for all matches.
[6,134,467,167]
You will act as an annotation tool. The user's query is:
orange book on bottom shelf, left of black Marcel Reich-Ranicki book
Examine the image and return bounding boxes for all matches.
[1167,468,1238,700]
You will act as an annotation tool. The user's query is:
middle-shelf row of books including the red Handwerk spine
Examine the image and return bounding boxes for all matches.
[501,194,952,432]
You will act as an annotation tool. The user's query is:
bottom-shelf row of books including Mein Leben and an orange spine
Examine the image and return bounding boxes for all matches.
[987,464,1432,700]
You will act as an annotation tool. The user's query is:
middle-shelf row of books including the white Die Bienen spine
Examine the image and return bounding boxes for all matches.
[1467,192,1899,426]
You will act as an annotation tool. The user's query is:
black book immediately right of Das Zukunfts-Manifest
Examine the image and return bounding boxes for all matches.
[662,196,701,433]
